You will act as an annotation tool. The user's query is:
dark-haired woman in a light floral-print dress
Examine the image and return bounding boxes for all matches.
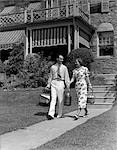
[70,58,92,120]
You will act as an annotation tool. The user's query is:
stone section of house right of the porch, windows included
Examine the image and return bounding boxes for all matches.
[89,0,117,74]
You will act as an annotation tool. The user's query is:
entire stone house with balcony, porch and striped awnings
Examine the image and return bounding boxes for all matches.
[0,0,117,74]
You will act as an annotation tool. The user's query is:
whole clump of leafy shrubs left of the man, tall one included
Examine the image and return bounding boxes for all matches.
[4,44,54,88]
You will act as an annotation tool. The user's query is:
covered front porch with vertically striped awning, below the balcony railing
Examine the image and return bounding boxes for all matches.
[25,17,94,56]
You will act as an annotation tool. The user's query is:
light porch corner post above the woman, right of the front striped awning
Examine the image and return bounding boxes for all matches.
[73,19,79,49]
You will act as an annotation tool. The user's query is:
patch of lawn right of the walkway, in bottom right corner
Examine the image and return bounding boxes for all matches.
[35,105,117,150]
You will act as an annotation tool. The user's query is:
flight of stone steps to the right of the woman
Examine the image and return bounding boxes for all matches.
[88,74,116,108]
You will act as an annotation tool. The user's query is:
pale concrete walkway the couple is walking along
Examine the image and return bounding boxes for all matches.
[0,107,111,150]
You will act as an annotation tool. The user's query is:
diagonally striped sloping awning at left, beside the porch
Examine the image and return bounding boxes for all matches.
[0,30,25,50]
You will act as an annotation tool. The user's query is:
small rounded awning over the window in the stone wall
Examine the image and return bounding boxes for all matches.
[97,23,114,32]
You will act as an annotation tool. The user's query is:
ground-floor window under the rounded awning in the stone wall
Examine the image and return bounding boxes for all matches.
[98,31,114,56]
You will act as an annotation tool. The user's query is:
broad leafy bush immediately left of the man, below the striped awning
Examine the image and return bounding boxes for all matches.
[18,53,53,88]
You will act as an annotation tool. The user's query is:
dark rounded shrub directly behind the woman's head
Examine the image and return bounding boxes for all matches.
[66,48,94,76]
